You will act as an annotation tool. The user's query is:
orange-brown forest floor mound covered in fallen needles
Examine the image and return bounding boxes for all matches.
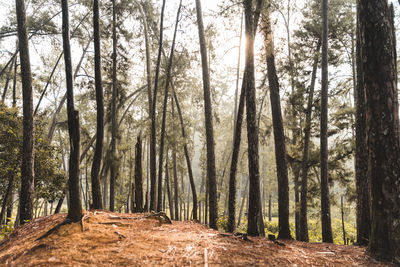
[0,211,390,266]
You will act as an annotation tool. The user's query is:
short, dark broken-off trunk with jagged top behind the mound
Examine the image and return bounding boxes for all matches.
[134,134,143,212]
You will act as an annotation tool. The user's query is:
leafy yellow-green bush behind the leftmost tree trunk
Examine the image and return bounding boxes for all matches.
[0,105,65,205]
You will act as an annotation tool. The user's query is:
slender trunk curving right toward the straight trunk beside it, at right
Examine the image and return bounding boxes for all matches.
[299,39,321,242]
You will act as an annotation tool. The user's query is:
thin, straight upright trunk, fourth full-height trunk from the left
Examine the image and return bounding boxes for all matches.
[110,0,118,211]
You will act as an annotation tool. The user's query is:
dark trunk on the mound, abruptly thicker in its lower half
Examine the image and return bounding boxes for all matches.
[61,0,83,222]
